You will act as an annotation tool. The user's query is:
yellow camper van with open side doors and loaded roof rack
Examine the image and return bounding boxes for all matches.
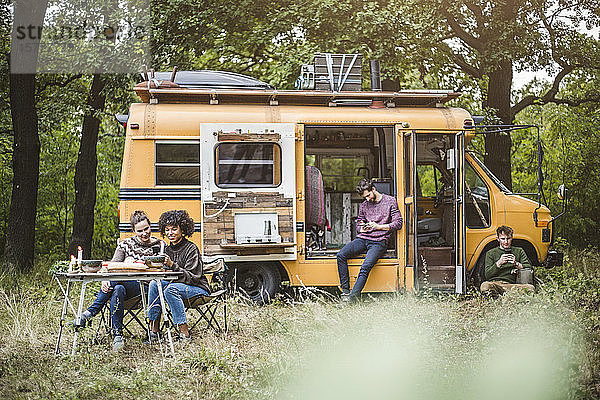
[119,66,552,301]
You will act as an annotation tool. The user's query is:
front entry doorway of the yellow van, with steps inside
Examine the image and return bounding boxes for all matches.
[399,129,466,293]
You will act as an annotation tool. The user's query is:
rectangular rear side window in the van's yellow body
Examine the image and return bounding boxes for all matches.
[155,141,200,186]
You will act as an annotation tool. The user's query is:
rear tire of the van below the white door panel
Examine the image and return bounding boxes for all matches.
[236,264,281,305]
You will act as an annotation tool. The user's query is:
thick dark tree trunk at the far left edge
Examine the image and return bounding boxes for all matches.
[3,0,48,271]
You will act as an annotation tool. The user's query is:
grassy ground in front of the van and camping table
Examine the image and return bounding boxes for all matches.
[0,252,600,400]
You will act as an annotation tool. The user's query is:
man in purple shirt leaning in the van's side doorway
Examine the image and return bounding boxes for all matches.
[337,179,402,301]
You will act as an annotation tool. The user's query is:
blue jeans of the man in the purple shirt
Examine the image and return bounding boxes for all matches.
[337,238,387,296]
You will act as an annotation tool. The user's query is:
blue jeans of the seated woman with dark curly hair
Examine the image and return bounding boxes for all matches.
[148,280,209,325]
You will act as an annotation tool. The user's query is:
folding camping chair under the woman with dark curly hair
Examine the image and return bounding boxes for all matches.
[169,259,227,333]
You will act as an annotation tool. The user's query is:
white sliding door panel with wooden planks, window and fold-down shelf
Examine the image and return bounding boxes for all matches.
[200,123,297,261]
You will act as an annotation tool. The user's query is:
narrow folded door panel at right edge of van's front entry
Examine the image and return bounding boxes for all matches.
[453,131,467,294]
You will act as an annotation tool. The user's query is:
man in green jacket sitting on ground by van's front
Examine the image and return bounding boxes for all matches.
[481,225,535,295]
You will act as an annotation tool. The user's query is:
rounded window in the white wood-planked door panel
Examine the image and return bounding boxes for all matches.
[215,143,281,187]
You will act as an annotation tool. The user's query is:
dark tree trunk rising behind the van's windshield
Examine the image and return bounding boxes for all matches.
[483,60,513,190]
